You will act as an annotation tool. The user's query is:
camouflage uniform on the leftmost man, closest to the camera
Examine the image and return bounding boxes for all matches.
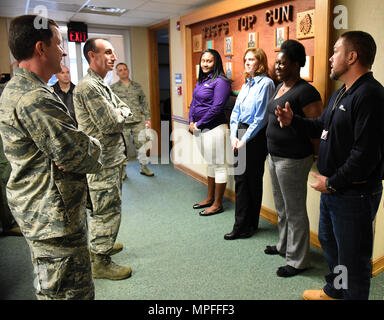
[0,68,102,299]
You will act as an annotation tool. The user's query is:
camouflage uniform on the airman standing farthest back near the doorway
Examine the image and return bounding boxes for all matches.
[111,80,151,165]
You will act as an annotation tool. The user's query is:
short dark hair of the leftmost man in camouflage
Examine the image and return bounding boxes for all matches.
[8,14,59,61]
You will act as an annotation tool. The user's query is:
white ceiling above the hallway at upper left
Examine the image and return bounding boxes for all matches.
[0,0,222,27]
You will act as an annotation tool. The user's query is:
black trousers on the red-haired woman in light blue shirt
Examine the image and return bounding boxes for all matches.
[233,124,267,232]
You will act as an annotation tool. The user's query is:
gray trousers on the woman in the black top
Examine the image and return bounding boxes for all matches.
[268,155,313,269]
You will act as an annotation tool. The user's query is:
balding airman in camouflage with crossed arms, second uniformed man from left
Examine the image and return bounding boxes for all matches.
[73,38,132,280]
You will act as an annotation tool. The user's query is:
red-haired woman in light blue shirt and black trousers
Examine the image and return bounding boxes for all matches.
[224,48,275,240]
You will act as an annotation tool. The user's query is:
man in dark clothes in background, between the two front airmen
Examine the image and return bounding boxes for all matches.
[52,65,77,126]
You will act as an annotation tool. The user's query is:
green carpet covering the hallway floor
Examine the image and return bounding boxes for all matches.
[0,161,384,300]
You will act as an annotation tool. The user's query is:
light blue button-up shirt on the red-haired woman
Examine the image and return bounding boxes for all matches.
[230,74,275,143]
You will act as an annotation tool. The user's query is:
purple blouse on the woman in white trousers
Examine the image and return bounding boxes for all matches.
[189,74,232,130]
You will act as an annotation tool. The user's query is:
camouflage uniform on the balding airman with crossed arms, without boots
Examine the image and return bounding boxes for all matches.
[73,69,131,255]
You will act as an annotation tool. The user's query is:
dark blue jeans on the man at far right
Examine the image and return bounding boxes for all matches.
[319,185,382,300]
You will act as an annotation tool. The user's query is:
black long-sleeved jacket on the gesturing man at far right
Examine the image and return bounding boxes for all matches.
[292,72,384,193]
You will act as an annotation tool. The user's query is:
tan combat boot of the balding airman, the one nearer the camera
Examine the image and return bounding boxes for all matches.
[92,254,132,280]
